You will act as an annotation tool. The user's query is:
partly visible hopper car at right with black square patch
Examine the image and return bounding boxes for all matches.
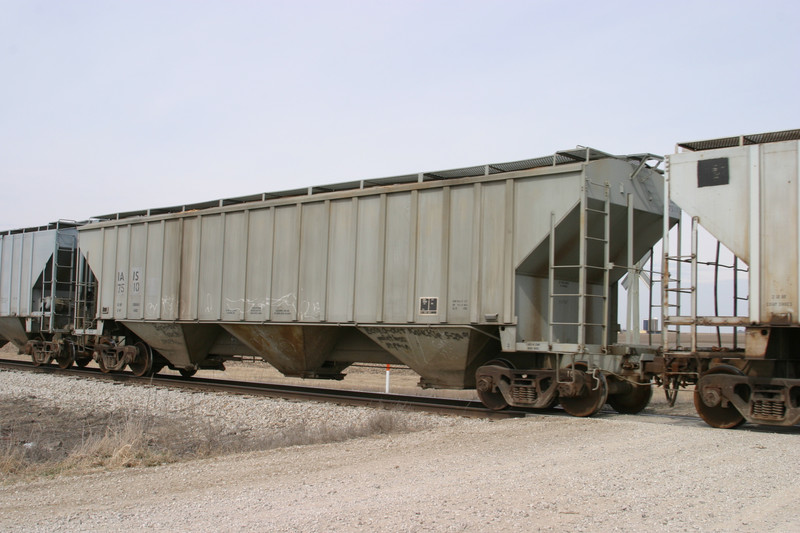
[647,130,800,428]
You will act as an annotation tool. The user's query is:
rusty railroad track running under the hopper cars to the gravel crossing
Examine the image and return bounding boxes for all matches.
[0,359,541,419]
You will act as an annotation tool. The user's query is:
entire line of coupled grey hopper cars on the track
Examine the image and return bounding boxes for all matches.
[0,130,800,428]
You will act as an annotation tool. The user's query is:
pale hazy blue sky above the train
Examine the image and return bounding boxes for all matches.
[0,0,800,230]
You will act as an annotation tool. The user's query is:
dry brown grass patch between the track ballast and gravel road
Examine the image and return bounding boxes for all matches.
[0,397,416,482]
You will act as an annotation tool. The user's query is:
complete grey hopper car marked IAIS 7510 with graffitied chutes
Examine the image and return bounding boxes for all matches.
[73,148,677,415]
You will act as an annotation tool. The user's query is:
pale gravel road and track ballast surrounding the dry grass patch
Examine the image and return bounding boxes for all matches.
[0,371,800,532]
